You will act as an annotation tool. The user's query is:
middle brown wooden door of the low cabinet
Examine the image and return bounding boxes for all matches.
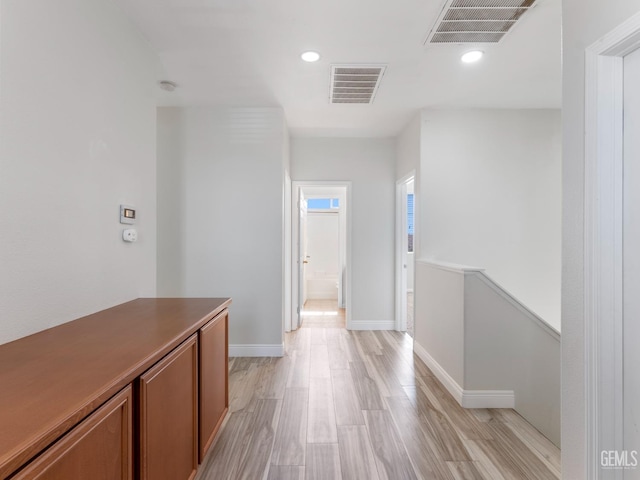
[139,334,198,480]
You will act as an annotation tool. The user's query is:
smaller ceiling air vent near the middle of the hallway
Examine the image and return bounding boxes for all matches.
[329,65,386,103]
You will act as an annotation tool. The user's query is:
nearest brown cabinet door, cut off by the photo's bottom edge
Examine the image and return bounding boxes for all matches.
[12,386,133,480]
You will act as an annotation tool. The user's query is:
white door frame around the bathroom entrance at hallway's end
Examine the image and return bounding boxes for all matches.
[285,180,352,332]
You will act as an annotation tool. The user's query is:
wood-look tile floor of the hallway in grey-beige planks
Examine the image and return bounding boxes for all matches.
[196,327,560,480]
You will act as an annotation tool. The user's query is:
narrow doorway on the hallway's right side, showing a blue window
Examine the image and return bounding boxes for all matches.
[396,173,415,337]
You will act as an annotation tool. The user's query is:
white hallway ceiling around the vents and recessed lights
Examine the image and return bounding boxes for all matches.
[114,0,561,136]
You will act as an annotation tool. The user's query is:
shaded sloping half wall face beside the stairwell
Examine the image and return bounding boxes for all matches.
[464,274,560,446]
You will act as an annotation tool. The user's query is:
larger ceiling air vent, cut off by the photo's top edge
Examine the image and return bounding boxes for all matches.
[425,0,536,45]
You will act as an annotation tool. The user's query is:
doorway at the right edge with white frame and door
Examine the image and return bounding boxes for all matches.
[584,14,640,480]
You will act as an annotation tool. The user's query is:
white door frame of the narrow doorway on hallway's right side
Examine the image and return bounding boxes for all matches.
[395,170,417,332]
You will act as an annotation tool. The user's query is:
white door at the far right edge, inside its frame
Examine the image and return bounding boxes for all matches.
[623,45,640,480]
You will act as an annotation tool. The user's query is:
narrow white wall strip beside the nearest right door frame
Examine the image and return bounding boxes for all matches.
[562,0,640,478]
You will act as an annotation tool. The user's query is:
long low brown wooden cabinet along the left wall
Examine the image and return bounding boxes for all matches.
[0,298,231,480]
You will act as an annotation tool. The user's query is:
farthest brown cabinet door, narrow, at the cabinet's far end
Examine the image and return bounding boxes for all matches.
[200,311,229,462]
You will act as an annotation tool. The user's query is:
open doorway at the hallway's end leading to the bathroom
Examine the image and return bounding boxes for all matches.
[285,182,351,331]
